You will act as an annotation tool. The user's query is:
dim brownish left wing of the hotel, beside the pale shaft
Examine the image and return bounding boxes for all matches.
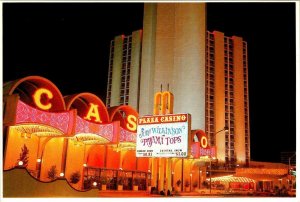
[106,30,142,109]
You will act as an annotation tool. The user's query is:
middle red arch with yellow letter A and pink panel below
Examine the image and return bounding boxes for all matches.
[65,93,117,144]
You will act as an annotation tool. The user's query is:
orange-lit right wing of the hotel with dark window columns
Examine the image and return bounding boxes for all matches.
[205,31,250,166]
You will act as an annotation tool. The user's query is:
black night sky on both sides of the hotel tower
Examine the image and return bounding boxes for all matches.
[3,2,296,162]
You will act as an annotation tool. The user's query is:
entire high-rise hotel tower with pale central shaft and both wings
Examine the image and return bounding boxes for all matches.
[106,3,250,167]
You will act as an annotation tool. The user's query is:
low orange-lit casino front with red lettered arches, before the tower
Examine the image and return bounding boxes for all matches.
[3,76,210,197]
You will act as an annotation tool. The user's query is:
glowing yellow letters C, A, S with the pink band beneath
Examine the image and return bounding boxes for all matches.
[16,88,138,142]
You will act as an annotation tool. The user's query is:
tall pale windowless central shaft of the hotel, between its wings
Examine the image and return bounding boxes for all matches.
[139,3,206,130]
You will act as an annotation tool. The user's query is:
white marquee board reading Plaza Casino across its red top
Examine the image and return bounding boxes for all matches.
[136,114,190,157]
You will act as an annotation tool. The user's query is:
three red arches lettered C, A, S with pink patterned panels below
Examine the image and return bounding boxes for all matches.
[4,76,138,174]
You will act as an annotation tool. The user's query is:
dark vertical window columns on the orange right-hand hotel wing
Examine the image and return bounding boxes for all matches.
[206,33,250,164]
